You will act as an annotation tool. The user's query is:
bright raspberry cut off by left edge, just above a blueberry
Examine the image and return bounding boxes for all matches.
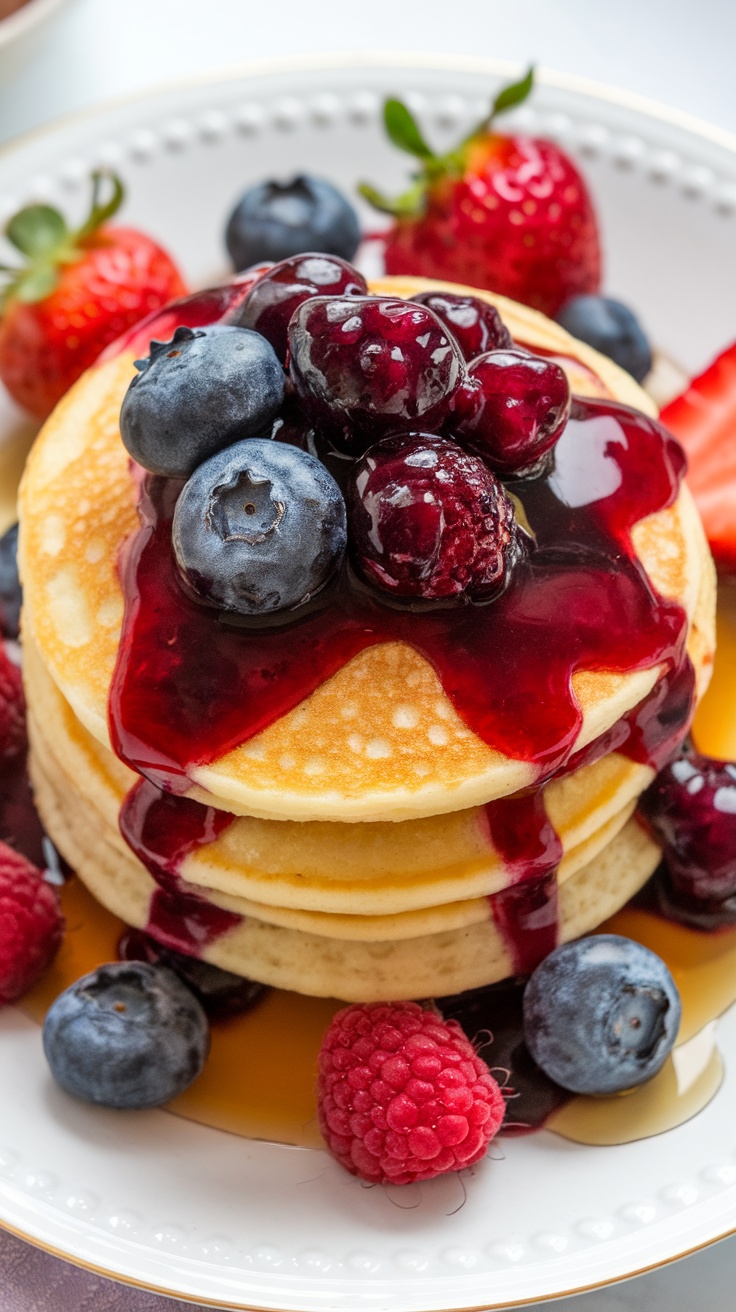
[0,842,64,1005]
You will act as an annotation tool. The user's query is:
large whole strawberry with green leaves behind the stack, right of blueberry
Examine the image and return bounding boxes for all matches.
[359,70,601,315]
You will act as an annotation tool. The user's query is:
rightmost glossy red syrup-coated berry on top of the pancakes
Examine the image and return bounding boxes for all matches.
[451,350,571,478]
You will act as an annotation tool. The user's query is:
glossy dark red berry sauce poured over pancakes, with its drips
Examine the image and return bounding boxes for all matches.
[109,289,693,972]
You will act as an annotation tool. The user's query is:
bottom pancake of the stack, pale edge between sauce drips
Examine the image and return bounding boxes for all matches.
[30,720,660,1002]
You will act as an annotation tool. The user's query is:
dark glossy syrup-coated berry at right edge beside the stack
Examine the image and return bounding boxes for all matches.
[640,752,736,911]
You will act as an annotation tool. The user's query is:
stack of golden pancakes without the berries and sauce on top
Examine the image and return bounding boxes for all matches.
[21,278,715,1001]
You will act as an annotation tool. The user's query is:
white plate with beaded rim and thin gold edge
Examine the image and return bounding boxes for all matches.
[0,55,736,1312]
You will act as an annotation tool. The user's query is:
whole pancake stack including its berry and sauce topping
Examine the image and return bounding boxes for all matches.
[21,255,715,1007]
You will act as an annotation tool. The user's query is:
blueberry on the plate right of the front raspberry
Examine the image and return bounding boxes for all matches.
[523,934,682,1094]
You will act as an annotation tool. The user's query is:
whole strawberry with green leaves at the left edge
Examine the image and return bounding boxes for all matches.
[0,172,186,420]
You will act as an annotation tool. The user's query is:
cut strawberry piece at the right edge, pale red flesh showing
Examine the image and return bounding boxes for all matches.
[660,342,736,576]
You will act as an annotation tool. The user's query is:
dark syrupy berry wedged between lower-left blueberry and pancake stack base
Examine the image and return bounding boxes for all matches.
[118,929,268,1021]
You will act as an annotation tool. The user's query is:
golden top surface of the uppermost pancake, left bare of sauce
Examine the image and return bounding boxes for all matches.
[21,279,708,820]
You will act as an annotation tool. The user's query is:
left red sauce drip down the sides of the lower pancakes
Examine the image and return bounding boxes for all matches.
[119,779,236,956]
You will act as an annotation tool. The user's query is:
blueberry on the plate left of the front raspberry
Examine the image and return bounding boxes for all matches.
[43,962,210,1107]
